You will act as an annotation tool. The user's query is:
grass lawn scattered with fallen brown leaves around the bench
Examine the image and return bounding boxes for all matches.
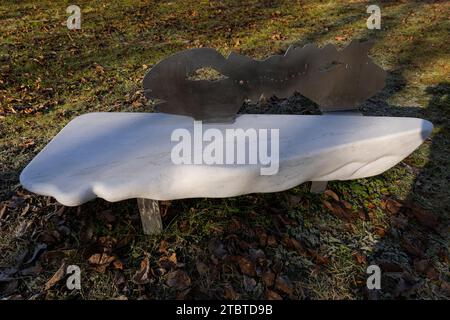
[0,0,450,299]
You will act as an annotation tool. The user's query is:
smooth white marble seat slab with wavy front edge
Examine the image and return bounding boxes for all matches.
[20,112,432,206]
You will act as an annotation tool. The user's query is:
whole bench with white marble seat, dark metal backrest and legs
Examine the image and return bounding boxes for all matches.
[20,40,432,234]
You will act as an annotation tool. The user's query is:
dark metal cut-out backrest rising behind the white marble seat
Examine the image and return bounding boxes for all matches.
[144,41,386,122]
